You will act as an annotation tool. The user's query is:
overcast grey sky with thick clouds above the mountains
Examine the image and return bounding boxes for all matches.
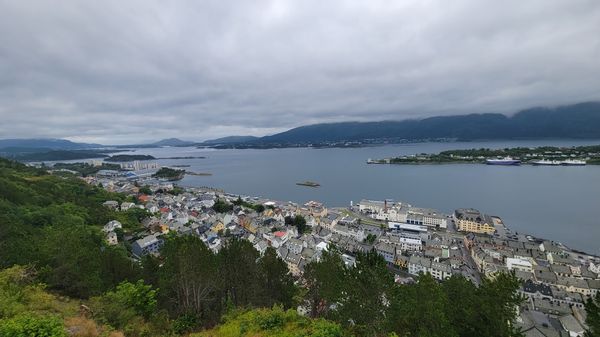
[0,0,600,144]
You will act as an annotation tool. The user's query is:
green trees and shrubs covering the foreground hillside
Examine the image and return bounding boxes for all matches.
[0,160,597,337]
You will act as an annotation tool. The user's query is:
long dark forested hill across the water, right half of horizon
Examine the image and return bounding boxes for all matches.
[251,102,600,144]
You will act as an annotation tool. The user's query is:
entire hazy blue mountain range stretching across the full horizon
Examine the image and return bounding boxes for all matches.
[0,102,600,155]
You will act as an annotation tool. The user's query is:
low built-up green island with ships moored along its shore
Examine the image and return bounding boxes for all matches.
[367,145,600,166]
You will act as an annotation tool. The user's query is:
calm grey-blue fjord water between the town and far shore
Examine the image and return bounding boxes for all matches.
[127,140,600,254]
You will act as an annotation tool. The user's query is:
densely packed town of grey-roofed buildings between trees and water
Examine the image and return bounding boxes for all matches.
[84,174,600,336]
